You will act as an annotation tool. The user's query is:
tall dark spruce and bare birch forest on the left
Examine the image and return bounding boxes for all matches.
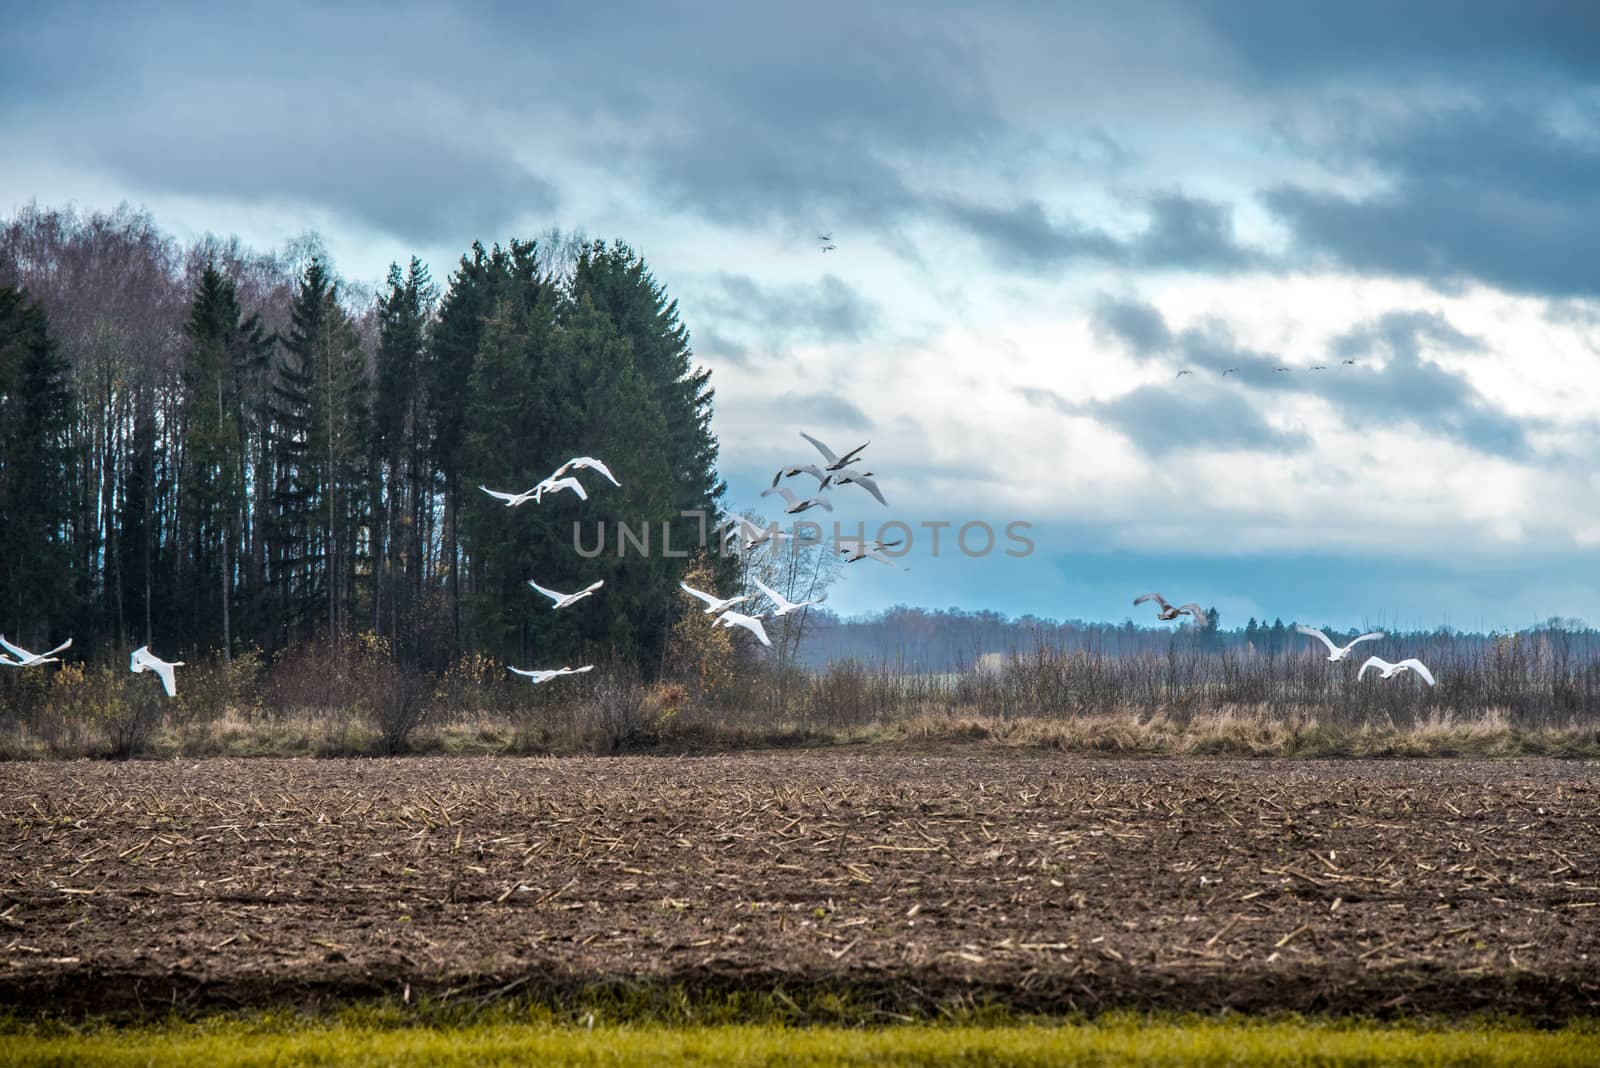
[0,208,723,670]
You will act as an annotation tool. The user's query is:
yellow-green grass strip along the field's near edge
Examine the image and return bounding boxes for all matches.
[0,1017,1600,1068]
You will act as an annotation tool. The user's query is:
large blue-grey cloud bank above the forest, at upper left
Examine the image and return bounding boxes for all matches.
[0,3,1005,241]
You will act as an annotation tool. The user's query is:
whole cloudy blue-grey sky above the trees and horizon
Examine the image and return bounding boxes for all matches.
[0,0,1600,627]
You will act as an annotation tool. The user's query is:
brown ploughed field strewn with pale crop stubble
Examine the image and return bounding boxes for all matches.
[0,750,1600,1018]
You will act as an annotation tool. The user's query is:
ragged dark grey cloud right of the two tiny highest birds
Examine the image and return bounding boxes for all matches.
[944,193,1266,272]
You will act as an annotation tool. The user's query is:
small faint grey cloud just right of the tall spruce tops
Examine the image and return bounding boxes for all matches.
[698,273,882,342]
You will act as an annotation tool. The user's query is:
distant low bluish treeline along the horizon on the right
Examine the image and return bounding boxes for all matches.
[797,604,1600,673]
